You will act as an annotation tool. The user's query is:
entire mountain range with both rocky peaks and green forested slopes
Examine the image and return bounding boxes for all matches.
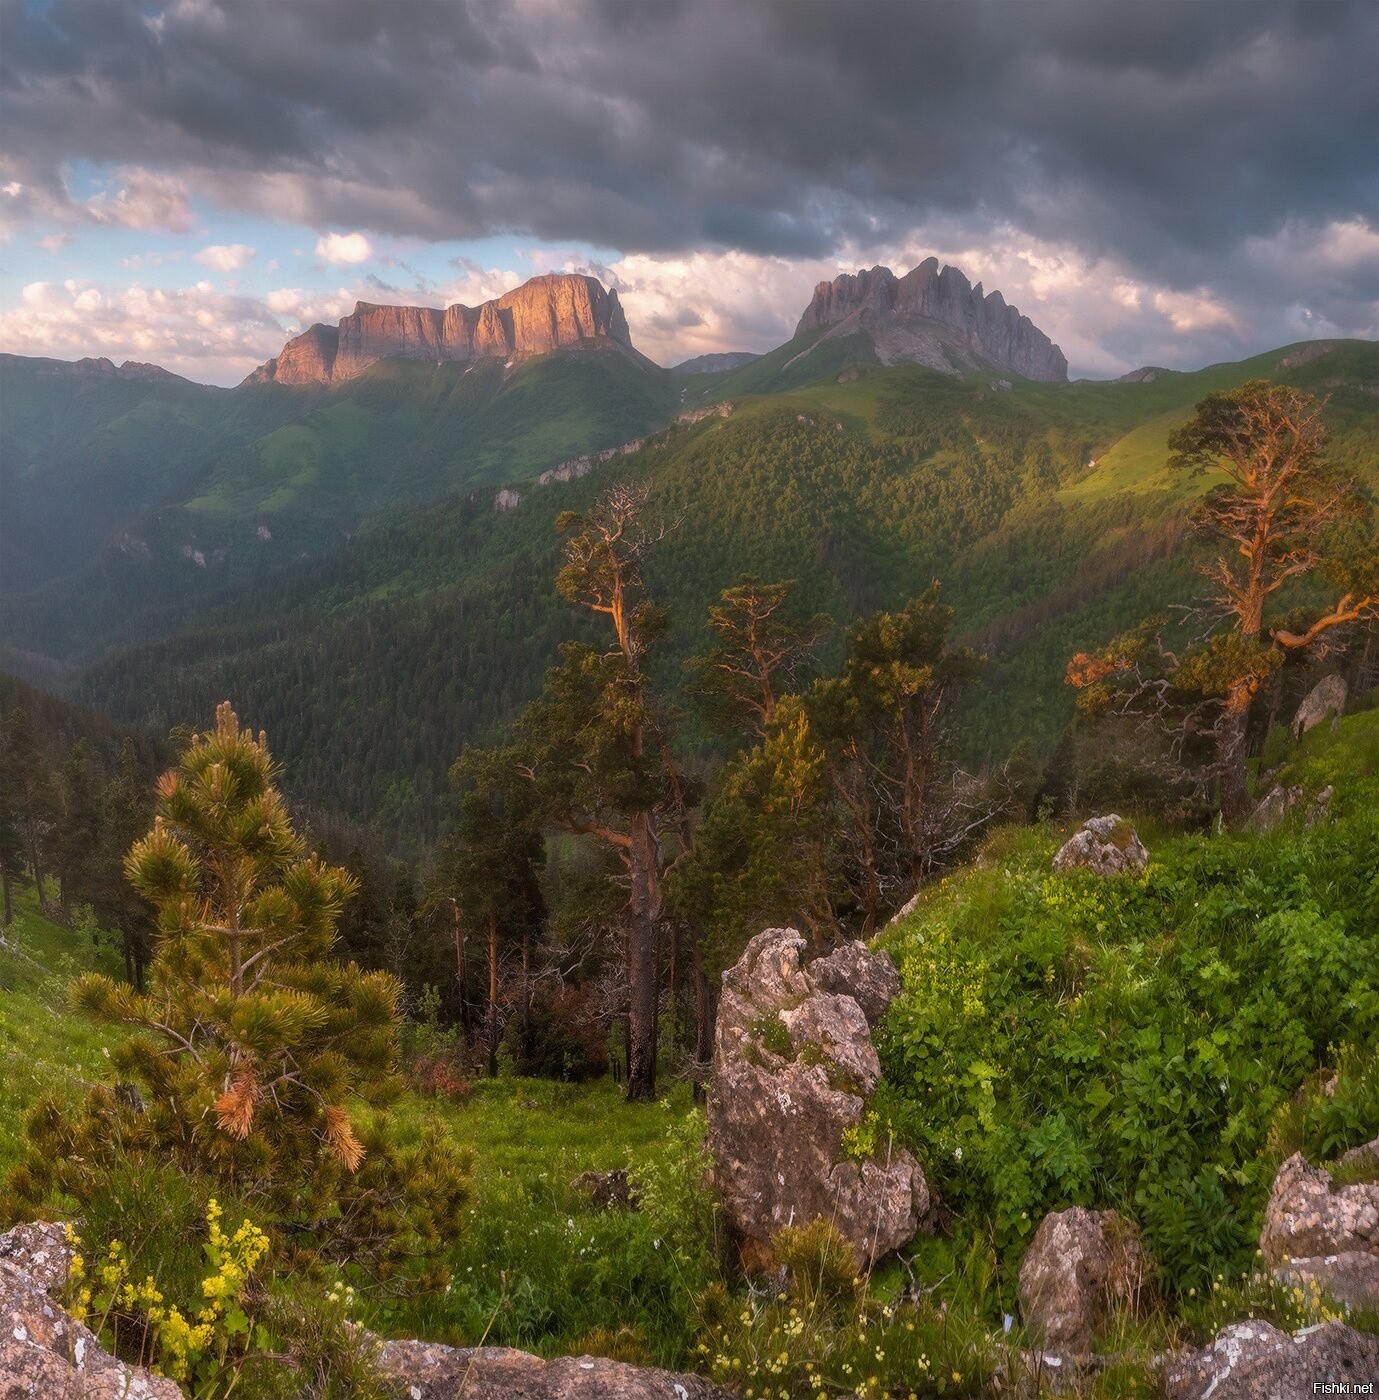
[0,259,1379,848]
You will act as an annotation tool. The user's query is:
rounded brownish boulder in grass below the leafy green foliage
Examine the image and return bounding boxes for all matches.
[1019,1205,1149,1355]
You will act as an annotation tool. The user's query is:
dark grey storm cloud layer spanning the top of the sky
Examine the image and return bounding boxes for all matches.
[0,0,1379,279]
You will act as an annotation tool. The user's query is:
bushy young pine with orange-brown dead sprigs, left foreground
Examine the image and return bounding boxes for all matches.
[11,701,465,1282]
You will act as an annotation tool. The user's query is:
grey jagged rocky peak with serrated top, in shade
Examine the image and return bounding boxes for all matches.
[795,258,1068,381]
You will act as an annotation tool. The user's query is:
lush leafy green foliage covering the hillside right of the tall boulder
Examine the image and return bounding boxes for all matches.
[872,714,1379,1292]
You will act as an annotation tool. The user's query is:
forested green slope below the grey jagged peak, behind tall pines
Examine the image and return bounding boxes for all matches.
[81,343,1379,843]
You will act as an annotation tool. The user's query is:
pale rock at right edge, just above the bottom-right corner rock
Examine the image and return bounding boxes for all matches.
[1260,1152,1379,1312]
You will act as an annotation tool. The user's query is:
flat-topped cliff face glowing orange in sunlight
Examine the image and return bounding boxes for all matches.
[248,273,631,384]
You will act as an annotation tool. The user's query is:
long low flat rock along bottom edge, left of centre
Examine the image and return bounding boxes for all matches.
[378,1341,736,1400]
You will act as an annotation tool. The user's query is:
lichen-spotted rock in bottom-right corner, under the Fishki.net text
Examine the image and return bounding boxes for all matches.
[1165,1322,1379,1400]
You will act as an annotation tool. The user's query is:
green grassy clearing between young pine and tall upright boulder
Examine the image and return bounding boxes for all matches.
[360,1078,713,1366]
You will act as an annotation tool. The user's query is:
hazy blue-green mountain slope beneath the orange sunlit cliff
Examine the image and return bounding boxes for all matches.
[0,341,675,663]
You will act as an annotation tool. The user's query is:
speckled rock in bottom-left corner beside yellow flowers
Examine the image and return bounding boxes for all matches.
[0,1222,182,1400]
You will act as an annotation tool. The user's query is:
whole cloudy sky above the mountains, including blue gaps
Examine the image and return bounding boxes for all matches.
[0,0,1379,384]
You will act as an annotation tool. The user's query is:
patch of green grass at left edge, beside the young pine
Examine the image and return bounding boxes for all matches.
[0,890,128,1175]
